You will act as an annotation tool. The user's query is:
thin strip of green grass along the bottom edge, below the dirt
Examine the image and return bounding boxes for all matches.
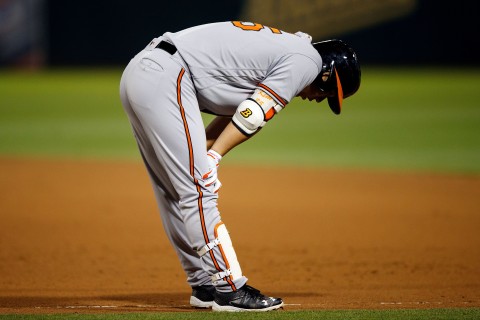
[0,309,480,320]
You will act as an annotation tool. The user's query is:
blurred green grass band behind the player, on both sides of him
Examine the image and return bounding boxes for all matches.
[0,67,480,174]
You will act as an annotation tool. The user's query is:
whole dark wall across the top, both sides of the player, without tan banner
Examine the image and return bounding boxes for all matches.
[0,0,480,66]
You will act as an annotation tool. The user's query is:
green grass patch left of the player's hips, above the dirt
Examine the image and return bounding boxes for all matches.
[0,70,133,157]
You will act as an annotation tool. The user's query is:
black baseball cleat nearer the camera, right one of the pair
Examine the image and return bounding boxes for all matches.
[212,285,283,312]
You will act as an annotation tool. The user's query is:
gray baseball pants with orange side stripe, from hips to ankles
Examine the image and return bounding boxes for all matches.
[121,43,247,291]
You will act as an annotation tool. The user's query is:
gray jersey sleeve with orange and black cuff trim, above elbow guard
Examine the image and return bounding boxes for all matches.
[258,54,320,106]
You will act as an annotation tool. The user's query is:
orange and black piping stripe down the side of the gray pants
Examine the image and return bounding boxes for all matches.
[177,68,237,291]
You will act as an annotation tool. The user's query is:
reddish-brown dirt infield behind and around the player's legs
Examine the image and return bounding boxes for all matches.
[0,159,480,313]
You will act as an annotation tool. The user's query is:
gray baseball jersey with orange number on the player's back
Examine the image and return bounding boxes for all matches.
[163,21,322,116]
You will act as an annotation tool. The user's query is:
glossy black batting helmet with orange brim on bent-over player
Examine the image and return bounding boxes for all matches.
[313,40,361,114]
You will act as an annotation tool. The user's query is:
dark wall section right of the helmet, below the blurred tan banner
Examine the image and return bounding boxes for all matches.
[342,0,480,66]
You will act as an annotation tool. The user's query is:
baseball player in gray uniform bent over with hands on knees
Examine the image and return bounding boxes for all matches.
[120,21,360,311]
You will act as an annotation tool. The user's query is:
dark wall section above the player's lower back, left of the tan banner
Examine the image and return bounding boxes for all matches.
[48,0,243,65]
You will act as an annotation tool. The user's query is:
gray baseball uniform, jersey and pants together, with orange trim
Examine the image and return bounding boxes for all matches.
[120,21,322,292]
